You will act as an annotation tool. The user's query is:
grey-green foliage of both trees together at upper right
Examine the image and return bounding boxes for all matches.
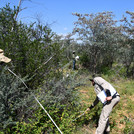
[73,11,134,76]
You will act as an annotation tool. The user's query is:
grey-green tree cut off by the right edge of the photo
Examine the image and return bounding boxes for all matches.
[120,11,134,77]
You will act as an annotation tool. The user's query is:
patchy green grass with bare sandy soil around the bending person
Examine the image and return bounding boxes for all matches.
[67,70,134,134]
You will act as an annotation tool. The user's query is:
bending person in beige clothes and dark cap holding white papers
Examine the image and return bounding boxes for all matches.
[86,77,120,134]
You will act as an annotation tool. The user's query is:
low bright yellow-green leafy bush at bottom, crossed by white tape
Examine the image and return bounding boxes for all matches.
[15,107,81,134]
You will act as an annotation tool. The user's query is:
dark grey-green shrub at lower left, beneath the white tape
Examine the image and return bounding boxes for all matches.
[0,68,32,132]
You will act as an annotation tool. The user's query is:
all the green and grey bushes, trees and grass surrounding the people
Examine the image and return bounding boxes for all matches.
[0,5,134,134]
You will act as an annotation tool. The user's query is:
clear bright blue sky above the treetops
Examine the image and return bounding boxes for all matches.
[0,0,134,35]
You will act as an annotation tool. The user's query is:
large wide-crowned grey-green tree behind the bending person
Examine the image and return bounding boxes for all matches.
[73,12,120,72]
